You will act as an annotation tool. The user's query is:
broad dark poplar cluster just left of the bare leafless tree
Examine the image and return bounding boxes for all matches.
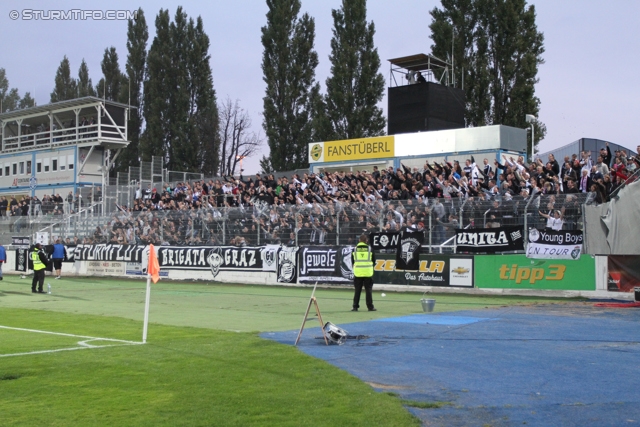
[140,7,219,175]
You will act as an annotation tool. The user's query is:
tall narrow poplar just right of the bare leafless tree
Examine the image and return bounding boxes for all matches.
[260,0,320,172]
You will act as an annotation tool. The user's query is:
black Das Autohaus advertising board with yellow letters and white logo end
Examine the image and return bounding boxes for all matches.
[373,254,473,287]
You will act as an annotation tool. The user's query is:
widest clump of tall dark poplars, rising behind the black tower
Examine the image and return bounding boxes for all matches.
[429,0,546,147]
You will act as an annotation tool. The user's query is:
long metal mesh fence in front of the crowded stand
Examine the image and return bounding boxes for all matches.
[29,193,594,253]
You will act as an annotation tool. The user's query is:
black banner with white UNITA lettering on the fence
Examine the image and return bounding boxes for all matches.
[456,227,524,253]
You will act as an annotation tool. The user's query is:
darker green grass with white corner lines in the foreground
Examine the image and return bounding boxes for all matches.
[0,308,416,426]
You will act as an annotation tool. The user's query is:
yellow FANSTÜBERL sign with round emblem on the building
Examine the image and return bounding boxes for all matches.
[309,135,395,163]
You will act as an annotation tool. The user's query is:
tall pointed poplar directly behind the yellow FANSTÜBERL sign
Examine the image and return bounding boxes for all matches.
[316,0,386,141]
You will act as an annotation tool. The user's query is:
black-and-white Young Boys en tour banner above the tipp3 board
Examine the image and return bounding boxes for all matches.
[527,228,583,259]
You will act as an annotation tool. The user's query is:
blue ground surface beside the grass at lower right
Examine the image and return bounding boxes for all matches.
[262,306,640,427]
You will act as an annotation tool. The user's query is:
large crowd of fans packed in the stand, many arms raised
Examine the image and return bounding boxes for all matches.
[75,144,640,246]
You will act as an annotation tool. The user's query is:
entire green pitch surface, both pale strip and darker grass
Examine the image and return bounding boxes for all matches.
[0,276,576,426]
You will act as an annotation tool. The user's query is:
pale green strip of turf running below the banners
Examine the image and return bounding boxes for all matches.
[0,275,580,332]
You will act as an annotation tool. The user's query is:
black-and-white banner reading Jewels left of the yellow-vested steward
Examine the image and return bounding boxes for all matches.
[298,246,353,283]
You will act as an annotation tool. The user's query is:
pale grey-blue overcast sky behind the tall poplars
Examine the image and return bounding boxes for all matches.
[0,0,640,173]
